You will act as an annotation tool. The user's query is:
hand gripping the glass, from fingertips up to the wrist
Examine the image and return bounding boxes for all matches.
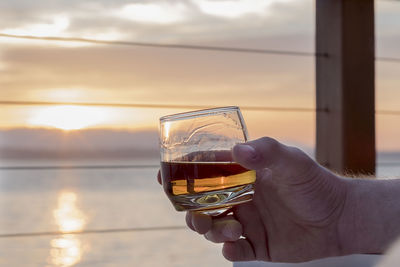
[186,137,348,262]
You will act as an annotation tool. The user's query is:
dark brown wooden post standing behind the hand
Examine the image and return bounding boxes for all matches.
[316,0,375,174]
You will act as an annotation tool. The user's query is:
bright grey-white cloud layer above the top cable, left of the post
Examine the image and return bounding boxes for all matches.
[0,0,313,42]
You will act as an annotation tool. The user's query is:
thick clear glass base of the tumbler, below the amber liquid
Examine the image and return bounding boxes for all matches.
[170,184,254,216]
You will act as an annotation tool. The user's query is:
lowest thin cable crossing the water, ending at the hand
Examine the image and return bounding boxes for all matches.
[0,226,187,238]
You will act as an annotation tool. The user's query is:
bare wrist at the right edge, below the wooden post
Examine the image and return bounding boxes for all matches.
[338,178,400,255]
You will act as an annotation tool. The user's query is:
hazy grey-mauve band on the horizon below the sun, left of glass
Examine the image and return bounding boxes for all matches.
[0,128,159,159]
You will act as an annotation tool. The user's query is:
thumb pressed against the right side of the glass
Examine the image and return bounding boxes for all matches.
[232,137,312,172]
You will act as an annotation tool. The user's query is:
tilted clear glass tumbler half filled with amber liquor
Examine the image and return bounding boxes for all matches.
[160,107,256,216]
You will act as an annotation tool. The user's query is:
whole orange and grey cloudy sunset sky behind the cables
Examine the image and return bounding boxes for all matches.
[0,0,400,150]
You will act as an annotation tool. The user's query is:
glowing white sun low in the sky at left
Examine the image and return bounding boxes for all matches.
[28,105,109,130]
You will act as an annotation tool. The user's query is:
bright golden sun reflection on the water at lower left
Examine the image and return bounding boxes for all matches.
[50,192,86,267]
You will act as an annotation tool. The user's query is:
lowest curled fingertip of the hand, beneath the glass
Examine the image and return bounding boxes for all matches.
[222,238,256,261]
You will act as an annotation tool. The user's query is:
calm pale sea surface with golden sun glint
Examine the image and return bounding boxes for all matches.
[0,154,400,267]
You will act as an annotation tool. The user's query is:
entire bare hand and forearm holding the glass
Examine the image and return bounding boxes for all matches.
[159,137,400,262]
